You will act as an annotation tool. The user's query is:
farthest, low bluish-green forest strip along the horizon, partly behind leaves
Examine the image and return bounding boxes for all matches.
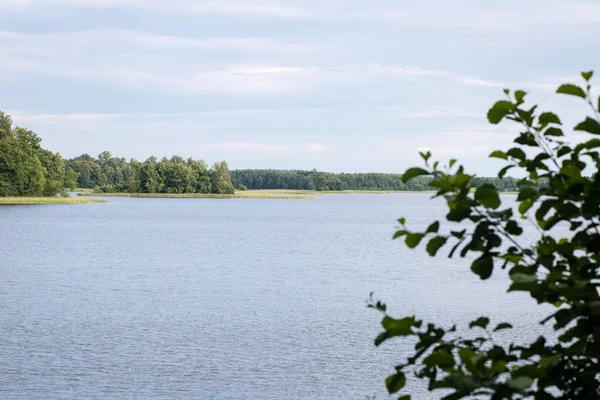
[231,169,519,191]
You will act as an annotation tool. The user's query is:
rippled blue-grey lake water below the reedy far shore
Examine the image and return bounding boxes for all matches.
[0,194,546,400]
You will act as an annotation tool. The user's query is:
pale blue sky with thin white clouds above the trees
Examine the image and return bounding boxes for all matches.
[0,0,600,175]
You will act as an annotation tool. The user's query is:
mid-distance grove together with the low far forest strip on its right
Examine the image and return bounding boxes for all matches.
[65,155,518,194]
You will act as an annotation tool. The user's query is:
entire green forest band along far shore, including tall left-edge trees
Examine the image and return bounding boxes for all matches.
[0,112,518,196]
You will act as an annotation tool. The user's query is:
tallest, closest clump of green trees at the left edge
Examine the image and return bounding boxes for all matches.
[0,111,77,197]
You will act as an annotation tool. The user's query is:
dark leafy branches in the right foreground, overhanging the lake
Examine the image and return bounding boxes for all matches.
[370,72,600,400]
